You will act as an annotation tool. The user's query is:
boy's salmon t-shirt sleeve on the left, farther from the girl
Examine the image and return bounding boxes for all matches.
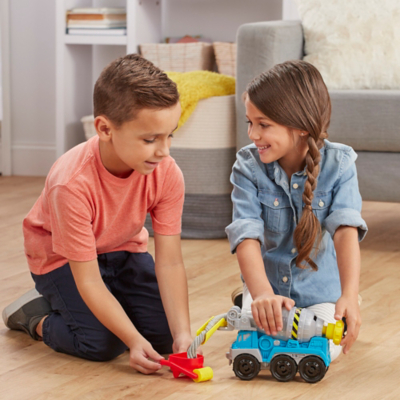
[48,186,97,261]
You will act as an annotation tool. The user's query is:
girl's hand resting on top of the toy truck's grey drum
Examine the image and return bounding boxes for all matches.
[251,294,294,336]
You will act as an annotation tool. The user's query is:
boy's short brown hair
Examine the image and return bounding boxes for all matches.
[93,54,179,127]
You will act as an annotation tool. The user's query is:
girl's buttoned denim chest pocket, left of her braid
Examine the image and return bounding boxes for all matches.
[258,191,293,233]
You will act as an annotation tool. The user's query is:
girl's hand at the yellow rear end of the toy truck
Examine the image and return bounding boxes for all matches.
[335,295,361,354]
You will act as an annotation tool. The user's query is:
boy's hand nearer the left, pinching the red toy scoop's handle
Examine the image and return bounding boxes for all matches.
[129,335,164,375]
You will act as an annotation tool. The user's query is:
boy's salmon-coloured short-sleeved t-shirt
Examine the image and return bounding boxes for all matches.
[23,136,185,275]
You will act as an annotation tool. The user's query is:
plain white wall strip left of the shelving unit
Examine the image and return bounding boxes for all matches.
[9,0,55,175]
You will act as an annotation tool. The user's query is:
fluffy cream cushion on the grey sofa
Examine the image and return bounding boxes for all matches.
[296,0,400,89]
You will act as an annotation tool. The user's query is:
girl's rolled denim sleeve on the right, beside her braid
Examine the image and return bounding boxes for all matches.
[322,149,368,241]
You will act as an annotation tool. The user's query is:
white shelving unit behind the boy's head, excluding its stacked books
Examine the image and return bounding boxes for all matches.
[56,0,162,157]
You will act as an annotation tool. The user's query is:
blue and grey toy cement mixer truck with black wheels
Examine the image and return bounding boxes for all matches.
[187,306,345,383]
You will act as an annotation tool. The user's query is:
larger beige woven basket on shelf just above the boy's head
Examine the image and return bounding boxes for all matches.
[139,42,214,72]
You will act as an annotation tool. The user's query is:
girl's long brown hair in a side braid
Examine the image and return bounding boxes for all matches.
[246,60,331,270]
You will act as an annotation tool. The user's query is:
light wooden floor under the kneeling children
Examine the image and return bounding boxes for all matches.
[0,177,400,400]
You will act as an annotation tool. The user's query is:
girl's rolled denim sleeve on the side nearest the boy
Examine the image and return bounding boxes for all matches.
[225,150,264,253]
